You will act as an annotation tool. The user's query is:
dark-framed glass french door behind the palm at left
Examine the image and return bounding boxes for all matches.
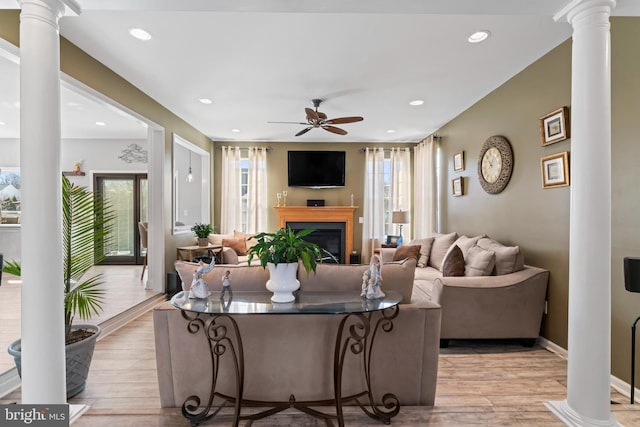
[93,173,149,265]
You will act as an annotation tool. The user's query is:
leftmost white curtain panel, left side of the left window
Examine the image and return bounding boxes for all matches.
[219,147,242,234]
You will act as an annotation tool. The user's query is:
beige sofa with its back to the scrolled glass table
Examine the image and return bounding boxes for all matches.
[153,258,440,407]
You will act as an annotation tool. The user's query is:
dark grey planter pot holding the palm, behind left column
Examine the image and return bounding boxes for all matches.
[7,325,101,399]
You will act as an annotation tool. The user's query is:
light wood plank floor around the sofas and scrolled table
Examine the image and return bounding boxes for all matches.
[0,268,640,427]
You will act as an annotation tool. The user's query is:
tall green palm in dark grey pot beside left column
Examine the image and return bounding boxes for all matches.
[3,176,115,398]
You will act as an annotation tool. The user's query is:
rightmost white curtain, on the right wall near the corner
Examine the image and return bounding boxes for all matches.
[413,135,440,238]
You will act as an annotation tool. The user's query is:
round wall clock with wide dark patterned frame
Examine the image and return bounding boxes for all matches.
[478,135,513,194]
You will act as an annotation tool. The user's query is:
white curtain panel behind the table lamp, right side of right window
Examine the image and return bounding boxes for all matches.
[389,148,412,243]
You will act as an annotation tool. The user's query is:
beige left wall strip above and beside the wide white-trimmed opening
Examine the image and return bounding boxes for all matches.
[0,10,213,281]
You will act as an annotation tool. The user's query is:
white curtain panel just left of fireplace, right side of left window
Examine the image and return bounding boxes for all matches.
[244,147,267,233]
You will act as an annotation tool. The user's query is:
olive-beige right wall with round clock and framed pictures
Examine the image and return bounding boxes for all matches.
[438,18,640,381]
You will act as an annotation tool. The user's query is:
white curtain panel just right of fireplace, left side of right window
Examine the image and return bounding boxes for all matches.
[362,148,384,264]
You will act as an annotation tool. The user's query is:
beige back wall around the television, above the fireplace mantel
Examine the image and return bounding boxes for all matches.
[214,140,415,253]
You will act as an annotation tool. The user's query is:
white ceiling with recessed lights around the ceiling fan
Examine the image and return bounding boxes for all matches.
[0,0,640,142]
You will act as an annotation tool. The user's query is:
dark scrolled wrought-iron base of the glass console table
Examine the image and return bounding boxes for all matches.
[170,290,400,427]
